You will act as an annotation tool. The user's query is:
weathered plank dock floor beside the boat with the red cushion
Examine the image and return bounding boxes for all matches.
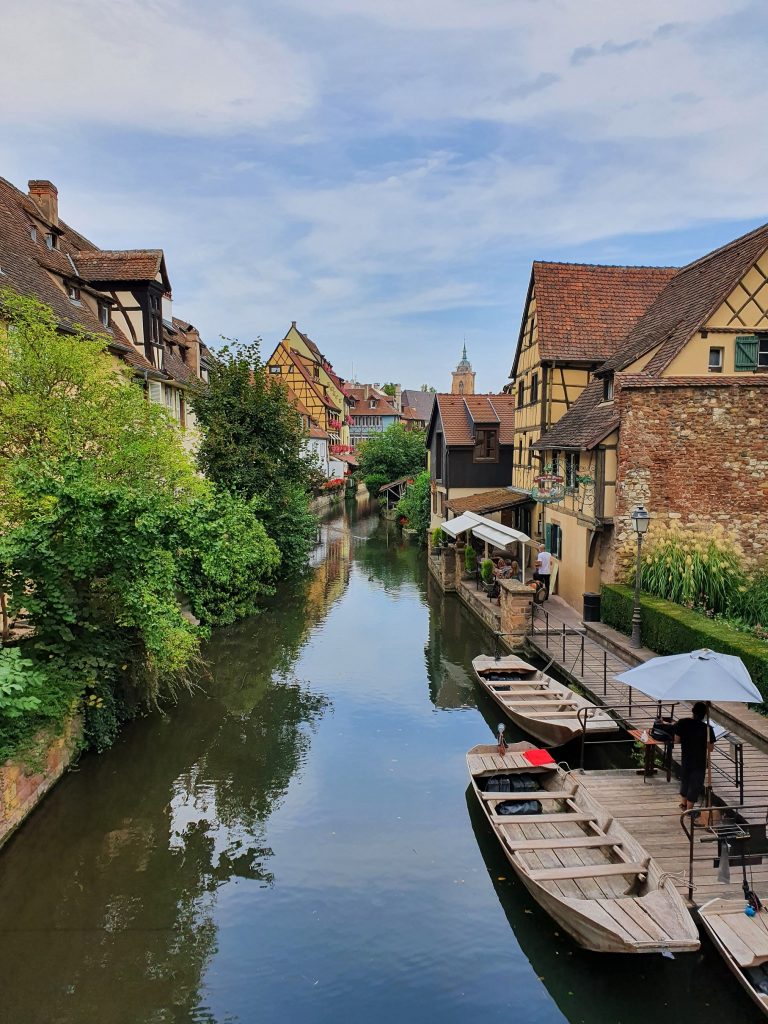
[579,769,768,906]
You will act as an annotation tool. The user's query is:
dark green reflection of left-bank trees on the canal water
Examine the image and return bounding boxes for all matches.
[0,528,335,1024]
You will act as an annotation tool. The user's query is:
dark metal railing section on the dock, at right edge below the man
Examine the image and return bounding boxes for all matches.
[680,803,768,903]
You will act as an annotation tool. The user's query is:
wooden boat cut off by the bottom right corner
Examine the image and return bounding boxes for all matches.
[698,897,768,1016]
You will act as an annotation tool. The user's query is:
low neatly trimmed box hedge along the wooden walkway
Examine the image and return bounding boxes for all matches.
[600,584,768,713]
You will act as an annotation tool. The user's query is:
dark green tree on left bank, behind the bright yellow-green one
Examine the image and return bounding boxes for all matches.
[191,341,317,573]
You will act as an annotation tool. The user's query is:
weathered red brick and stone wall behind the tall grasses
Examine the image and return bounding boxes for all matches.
[605,375,768,579]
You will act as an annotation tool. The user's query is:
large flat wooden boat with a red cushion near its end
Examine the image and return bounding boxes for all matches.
[467,744,699,953]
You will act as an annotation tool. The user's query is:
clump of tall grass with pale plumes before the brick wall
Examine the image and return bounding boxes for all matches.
[628,523,745,612]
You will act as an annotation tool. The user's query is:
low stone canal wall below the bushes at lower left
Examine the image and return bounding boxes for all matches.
[0,715,83,846]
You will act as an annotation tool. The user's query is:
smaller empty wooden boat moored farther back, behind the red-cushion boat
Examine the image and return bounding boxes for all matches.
[472,654,620,746]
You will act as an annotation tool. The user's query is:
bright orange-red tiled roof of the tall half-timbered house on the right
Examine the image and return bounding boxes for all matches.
[520,260,677,373]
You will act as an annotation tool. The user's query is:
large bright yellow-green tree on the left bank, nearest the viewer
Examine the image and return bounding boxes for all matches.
[0,291,279,751]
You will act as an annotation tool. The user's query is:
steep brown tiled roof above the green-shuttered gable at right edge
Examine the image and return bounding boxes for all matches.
[599,224,768,375]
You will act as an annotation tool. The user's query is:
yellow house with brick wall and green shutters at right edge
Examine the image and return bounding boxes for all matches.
[537,225,768,607]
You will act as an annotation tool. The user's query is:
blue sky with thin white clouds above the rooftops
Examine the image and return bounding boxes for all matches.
[0,0,768,391]
